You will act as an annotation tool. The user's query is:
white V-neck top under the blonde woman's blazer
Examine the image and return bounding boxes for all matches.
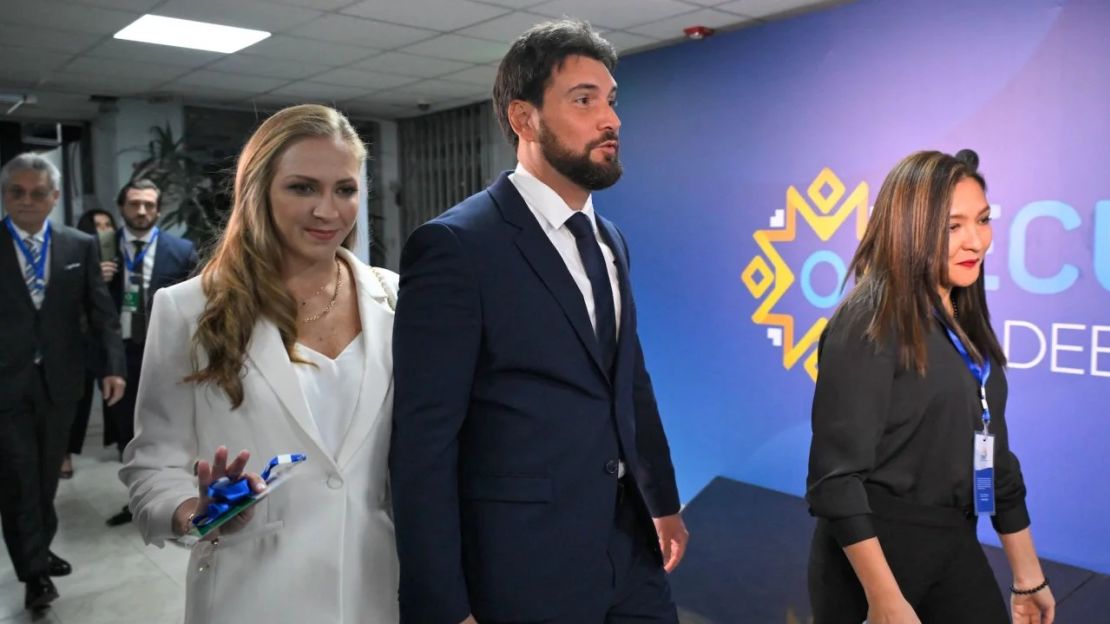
[293,333,366,457]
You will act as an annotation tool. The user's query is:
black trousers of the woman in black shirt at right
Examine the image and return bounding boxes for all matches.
[809,487,1010,624]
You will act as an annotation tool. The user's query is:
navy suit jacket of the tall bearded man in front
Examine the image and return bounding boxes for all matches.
[390,174,679,624]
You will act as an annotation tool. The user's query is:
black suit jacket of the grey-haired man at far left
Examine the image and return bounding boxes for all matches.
[0,223,127,403]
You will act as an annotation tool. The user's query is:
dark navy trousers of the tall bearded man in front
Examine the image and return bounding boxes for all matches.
[478,480,678,624]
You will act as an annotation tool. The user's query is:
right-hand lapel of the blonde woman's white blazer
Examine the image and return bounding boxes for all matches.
[335,250,393,470]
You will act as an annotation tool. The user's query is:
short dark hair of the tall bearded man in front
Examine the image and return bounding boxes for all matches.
[493,19,617,148]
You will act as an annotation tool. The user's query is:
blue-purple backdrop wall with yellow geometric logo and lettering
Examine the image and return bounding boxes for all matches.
[597,0,1110,573]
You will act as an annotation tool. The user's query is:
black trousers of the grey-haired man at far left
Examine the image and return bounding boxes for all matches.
[0,366,74,583]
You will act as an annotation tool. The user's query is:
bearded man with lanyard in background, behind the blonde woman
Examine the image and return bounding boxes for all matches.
[104,179,198,526]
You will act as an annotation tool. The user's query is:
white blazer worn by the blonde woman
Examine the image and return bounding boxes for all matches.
[120,250,400,624]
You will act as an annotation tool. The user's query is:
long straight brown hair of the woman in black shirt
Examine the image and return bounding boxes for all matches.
[841,150,1006,374]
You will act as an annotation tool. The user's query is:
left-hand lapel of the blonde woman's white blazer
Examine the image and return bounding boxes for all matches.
[248,319,332,461]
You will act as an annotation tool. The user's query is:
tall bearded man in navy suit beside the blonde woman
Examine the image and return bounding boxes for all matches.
[390,21,688,624]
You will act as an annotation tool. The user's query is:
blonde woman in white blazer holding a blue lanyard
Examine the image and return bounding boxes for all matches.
[120,105,398,624]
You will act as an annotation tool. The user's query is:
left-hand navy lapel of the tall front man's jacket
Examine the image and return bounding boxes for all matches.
[488,173,609,379]
